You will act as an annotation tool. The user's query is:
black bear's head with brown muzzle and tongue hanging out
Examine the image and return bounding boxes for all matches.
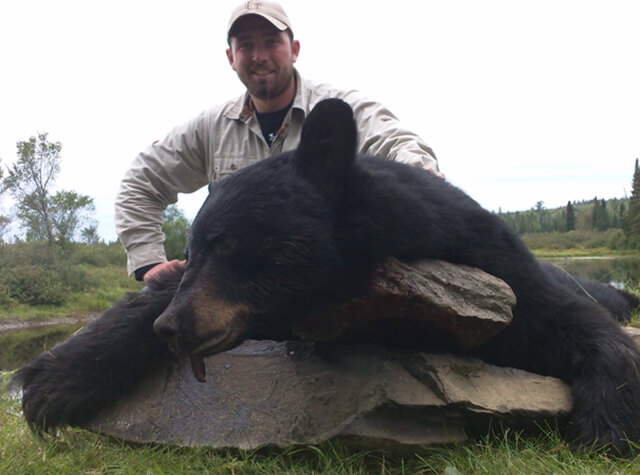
[154,99,357,380]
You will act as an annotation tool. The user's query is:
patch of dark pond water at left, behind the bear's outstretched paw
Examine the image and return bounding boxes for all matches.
[0,323,82,371]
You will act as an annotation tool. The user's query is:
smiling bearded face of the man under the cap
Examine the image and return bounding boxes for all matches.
[227,15,300,104]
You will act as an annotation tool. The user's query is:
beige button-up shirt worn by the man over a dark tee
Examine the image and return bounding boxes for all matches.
[116,72,438,274]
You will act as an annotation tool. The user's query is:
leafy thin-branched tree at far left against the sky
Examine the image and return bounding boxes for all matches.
[3,133,94,245]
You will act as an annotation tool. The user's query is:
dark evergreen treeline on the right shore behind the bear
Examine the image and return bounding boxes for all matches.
[497,159,640,249]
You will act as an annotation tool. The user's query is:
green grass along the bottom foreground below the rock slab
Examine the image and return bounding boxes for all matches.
[0,389,640,475]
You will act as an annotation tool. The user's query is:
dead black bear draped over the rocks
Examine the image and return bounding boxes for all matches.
[16,100,640,453]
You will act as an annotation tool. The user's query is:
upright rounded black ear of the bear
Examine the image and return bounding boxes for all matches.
[296,99,358,195]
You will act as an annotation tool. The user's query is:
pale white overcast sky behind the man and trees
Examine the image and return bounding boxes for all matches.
[0,0,640,241]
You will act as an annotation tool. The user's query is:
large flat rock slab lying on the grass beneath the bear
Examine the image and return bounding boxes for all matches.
[87,340,572,450]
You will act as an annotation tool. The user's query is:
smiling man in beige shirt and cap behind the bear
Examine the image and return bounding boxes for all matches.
[116,1,439,280]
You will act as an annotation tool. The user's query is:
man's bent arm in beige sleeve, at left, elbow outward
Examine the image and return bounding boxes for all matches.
[116,114,209,274]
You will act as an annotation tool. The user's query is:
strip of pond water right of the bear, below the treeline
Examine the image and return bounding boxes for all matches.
[544,257,640,288]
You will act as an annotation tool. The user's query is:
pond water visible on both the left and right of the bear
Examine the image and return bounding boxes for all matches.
[0,257,640,371]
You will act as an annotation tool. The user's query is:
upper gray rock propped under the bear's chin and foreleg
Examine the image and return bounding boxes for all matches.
[294,258,516,350]
